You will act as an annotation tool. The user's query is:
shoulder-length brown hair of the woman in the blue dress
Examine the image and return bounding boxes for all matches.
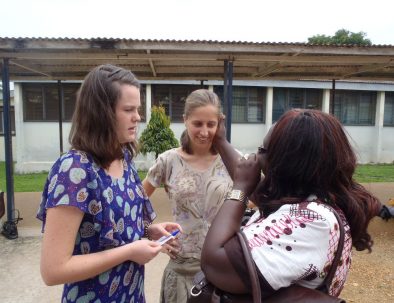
[69,64,140,168]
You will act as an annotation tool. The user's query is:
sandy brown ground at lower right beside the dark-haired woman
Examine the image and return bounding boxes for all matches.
[340,218,394,303]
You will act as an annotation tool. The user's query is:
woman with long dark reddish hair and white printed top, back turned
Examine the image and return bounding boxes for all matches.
[201,109,381,298]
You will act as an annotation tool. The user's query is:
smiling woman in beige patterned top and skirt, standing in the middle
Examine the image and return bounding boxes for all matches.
[143,89,232,303]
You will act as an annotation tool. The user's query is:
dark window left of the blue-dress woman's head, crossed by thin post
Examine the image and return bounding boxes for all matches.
[22,83,80,121]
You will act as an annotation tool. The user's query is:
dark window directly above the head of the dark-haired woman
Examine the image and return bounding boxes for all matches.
[272,88,323,121]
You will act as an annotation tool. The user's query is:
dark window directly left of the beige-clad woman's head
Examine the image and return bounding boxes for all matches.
[152,84,201,122]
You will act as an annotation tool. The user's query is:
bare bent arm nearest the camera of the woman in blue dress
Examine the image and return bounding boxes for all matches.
[41,206,161,285]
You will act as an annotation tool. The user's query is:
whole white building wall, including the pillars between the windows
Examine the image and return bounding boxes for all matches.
[4,81,394,173]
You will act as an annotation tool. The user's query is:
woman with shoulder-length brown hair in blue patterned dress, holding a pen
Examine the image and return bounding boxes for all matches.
[37,64,180,302]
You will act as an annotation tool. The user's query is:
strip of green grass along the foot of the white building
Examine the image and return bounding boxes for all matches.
[0,162,394,192]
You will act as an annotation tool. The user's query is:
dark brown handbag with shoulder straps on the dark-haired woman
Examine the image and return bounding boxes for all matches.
[187,209,346,303]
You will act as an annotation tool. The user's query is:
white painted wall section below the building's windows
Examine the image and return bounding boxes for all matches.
[4,122,394,173]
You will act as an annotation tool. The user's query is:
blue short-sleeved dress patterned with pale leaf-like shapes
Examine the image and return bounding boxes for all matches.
[37,150,156,303]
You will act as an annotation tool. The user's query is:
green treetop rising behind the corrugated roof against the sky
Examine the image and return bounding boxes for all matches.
[308,29,372,45]
